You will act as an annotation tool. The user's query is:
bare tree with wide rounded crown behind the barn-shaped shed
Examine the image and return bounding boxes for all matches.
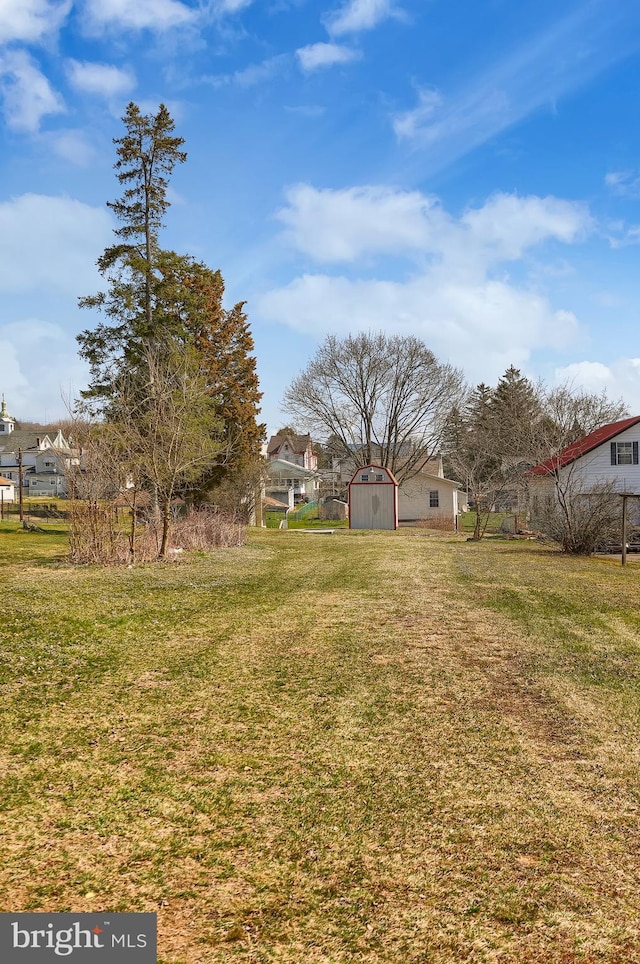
[284,333,463,482]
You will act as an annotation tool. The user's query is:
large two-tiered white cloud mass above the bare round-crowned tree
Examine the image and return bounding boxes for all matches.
[259,185,591,380]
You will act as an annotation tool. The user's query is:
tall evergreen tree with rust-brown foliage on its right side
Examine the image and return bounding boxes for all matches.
[78,104,265,520]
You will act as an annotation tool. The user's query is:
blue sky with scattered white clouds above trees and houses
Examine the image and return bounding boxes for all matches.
[0,0,640,431]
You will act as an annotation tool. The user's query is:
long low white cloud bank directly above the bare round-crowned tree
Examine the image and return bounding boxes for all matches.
[258,271,578,381]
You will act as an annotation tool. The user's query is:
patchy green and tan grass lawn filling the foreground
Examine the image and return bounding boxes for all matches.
[0,523,640,964]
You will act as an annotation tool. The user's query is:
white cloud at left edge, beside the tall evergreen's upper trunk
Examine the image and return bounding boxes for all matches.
[0,194,113,290]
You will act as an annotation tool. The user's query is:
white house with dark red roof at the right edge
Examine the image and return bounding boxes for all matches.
[527,415,640,515]
